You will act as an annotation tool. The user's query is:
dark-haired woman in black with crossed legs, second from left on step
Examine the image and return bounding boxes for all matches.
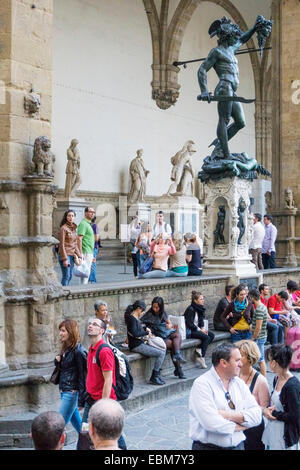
[141,297,186,379]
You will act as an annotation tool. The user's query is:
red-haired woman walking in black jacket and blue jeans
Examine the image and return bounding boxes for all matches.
[54,319,87,433]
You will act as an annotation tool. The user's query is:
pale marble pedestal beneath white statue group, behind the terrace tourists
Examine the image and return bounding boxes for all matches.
[151,196,203,238]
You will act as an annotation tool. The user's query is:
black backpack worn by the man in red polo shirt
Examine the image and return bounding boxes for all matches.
[96,343,133,401]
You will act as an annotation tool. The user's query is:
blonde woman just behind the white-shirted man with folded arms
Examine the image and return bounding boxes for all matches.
[235,340,270,450]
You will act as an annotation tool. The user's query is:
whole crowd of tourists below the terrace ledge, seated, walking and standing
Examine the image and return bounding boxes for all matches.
[28,276,300,450]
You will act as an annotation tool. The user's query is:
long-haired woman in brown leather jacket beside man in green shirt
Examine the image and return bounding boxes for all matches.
[58,210,82,286]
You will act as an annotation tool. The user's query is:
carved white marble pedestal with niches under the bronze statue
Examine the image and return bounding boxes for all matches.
[203,178,256,277]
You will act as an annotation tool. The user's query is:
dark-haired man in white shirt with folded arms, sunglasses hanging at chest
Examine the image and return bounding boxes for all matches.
[189,343,262,450]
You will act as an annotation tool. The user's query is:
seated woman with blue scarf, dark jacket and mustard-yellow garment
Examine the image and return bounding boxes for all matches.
[221,284,254,343]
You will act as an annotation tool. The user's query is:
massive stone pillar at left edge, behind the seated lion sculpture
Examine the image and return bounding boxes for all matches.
[0,0,60,369]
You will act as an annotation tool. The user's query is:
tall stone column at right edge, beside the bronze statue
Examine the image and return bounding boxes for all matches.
[271,0,300,266]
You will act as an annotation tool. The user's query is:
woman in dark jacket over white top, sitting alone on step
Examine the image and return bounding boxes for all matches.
[184,290,215,369]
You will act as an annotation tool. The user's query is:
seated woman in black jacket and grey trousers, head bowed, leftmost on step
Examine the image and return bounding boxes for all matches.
[124,300,166,385]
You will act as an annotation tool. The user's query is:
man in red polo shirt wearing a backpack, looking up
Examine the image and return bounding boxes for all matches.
[82,317,126,449]
